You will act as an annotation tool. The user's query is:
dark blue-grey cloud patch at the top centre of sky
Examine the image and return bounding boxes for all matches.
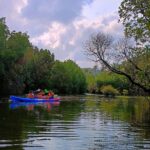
[22,0,93,24]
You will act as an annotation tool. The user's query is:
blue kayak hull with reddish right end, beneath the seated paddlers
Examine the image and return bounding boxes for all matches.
[10,96,60,102]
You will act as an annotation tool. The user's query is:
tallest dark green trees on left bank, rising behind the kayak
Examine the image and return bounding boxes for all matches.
[0,18,54,95]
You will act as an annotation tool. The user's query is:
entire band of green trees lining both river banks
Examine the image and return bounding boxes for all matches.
[0,4,150,96]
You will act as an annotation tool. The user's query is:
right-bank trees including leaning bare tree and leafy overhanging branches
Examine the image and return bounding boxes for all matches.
[85,0,150,95]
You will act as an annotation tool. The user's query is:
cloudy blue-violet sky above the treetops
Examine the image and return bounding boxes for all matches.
[0,0,123,68]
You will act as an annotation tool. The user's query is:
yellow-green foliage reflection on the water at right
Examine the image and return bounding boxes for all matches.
[99,97,150,127]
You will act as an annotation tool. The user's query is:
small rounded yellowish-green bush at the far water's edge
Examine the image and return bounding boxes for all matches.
[101,85,119,96]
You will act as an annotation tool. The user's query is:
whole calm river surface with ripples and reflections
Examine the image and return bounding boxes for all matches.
[0,96,150,150]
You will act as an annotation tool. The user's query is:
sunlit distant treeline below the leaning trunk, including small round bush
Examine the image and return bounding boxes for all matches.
[84,67,144,95]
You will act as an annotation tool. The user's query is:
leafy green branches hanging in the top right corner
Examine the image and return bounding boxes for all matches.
[119,0,150,44]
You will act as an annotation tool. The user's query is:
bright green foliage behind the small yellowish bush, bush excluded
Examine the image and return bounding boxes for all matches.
[85,70,129,93]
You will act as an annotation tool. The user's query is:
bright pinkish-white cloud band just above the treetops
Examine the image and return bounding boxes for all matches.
[32,13,122,67]
